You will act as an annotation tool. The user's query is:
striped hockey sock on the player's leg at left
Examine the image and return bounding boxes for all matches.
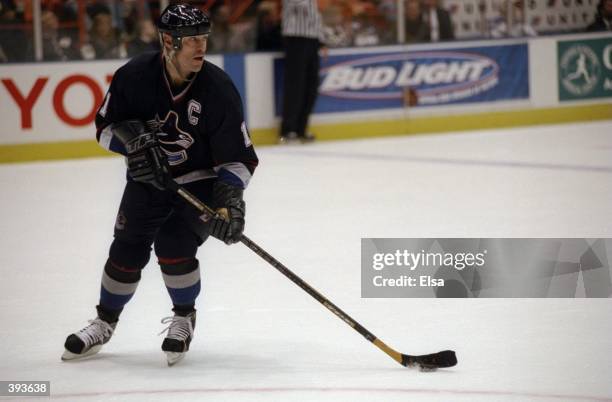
[98,259,141,321]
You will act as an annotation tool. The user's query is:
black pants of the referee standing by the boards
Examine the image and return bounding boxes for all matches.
[281,36,319,137]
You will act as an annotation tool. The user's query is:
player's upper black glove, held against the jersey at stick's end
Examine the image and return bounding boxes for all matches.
[112,120,172,190]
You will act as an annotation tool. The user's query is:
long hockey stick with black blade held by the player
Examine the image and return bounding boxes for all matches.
[170,181,457,371]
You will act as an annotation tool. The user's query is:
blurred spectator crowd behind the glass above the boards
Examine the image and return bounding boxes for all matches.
[0,0,612,62]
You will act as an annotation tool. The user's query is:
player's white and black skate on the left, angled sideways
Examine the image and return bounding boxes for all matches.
[62,317,117,361]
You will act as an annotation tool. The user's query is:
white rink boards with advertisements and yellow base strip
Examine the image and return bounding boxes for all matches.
[0,34,612,162]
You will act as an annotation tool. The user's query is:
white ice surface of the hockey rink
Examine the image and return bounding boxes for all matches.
[0,121,612,401]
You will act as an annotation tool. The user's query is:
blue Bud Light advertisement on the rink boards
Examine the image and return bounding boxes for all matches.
[274,44,529,115]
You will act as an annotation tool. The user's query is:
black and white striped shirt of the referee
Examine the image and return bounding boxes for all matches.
[282,0,322,39]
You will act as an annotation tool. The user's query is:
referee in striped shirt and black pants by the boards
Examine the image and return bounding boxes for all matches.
[280,0,322,144]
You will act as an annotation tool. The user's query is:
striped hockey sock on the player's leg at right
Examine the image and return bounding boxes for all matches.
[158,257,201,315]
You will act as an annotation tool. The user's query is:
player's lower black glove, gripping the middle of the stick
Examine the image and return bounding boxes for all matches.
[211,182,246,244]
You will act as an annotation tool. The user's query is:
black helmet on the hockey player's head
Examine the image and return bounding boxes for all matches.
[157,4,211,49]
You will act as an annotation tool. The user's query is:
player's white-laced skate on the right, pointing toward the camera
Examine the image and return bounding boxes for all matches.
[159,311,196,366]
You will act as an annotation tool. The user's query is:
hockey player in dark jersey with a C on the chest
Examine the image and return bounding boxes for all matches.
[62,4,258,365]
